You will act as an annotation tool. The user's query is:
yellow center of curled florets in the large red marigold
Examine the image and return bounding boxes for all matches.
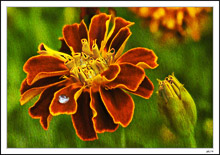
[66,39,113,86]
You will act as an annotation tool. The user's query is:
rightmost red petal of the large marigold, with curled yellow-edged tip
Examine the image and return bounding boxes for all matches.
[116,47,158,69]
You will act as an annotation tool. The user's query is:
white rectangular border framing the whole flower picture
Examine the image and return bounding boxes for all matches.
[1,1,219,154]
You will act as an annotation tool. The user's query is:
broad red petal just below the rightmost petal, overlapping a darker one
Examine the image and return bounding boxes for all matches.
[106,63,145,91]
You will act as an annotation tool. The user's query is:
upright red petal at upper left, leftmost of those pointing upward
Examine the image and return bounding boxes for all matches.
[63,20,88,53]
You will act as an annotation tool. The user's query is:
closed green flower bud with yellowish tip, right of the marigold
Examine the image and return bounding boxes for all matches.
[158,74,197,136]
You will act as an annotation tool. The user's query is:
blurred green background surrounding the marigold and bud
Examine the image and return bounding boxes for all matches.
[7,7,213,148]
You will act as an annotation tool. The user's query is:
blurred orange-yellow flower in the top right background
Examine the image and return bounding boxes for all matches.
[130,7,211,41]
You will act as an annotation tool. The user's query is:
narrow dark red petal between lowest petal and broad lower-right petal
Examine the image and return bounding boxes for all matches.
[90,88,119,133]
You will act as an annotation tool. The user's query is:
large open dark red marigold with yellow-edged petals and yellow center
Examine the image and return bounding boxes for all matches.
[20,13,158,140]
